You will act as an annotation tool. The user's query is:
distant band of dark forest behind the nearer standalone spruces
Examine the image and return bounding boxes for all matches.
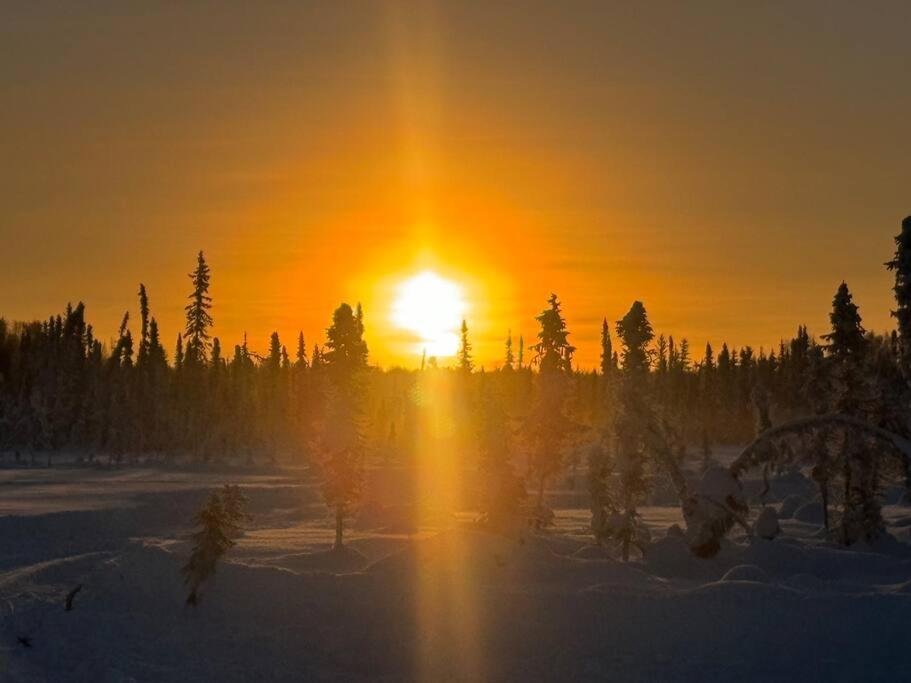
[0,222,911,470]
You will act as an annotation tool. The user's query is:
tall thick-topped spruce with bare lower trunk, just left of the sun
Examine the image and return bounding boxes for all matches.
[321,303,367,549]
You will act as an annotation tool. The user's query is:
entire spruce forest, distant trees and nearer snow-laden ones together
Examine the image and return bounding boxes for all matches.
[0,217,911,557]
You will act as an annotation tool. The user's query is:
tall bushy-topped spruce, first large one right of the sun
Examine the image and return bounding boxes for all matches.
[520,294,575,526]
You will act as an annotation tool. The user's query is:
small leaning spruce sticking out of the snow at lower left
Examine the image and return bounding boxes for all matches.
[181,486,246,607]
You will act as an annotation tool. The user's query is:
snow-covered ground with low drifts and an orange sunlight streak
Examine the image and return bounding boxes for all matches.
[0,468,911,682]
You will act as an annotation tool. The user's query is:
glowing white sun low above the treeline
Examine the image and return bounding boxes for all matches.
[392,270,468,357]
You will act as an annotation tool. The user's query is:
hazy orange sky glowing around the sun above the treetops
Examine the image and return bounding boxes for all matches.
[0,0,911,368]
